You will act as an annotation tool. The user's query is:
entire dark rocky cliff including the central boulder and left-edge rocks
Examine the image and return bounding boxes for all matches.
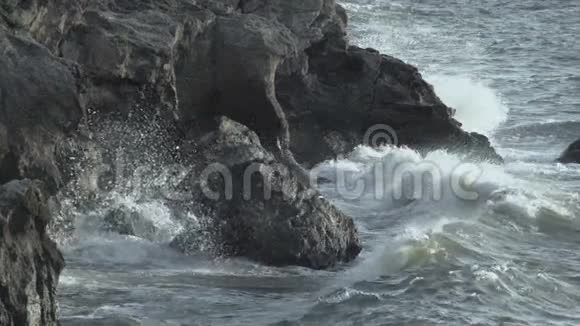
[0,0,501,325]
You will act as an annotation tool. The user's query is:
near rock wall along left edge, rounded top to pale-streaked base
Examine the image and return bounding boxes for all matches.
[0,24,73,326]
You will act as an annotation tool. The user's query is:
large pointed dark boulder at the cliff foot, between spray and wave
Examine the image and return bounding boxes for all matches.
[172,118,361,268]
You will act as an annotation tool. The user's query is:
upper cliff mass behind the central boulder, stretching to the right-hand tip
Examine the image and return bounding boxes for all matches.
[3,0,501,166]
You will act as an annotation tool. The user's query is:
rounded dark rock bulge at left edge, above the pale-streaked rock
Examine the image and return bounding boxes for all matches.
[0,27,83,191]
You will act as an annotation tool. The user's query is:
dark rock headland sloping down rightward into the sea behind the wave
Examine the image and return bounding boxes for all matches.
[277,41,502,165]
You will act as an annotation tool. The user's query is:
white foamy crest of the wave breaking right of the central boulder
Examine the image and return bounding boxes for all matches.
[314,146,515,210]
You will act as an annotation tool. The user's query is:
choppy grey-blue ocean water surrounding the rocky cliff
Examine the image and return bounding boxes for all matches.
[59,0,580,326]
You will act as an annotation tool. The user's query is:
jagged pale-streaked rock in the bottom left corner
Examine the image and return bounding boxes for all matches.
[0,180,64,326]
